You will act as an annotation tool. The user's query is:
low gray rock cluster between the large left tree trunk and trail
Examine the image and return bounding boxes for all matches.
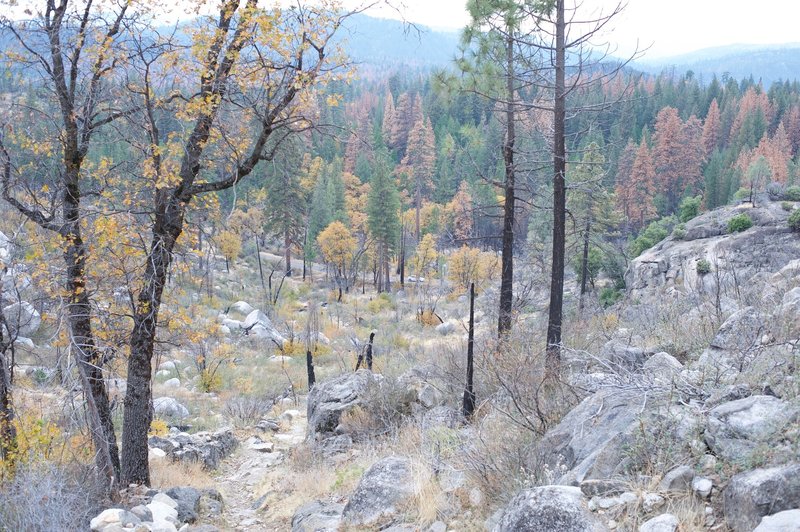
[148,429,239,469]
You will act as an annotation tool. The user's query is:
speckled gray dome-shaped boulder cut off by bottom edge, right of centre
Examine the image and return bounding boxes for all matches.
[493,486,606,532]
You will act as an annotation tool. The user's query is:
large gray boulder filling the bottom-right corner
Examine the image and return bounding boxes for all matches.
[723,463,800,532]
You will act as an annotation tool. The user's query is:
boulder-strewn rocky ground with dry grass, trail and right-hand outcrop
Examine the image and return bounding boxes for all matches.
[7,197,800,532]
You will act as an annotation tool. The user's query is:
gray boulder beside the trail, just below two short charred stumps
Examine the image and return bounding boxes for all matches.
[307,369,378,439]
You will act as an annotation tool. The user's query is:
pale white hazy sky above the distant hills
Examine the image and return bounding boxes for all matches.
[366,0,800,59]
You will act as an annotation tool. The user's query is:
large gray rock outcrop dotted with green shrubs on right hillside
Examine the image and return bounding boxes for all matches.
[625,202,800,302]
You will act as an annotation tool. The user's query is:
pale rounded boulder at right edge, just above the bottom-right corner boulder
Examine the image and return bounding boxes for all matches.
[705,395,798,460]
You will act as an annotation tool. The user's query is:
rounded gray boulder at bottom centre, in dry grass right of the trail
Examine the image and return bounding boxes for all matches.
[342,456,416,527]
